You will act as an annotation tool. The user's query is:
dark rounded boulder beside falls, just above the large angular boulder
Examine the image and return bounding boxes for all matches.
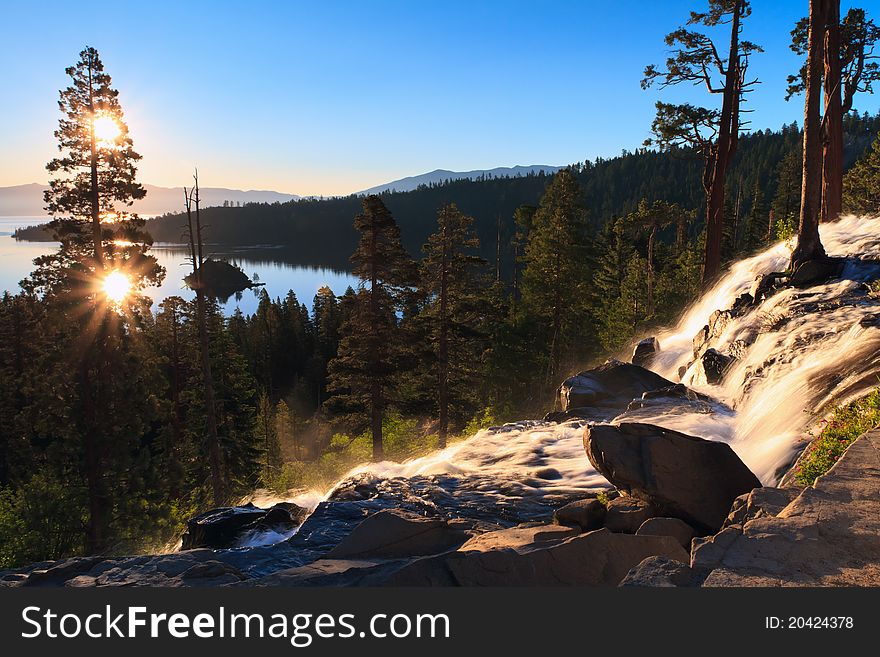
[558,360,674,411]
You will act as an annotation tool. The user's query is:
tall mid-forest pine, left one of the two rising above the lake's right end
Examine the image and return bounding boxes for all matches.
[328,195,415,461]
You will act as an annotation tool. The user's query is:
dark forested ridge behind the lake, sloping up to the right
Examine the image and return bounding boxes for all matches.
[141,113,880,279]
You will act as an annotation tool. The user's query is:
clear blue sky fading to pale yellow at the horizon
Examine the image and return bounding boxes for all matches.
[0,0,880,195]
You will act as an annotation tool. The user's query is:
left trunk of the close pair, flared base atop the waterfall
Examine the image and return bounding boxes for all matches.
[789,0,828,271]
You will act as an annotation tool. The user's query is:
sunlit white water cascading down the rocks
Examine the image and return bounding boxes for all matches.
[239,216,880,545]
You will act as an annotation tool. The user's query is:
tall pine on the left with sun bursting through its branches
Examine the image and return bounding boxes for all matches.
[23,48,164,552]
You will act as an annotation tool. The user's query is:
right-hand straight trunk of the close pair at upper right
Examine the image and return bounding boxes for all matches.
[822,0,843,221]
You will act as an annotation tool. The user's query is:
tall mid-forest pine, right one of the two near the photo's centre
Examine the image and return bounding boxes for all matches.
[419,204,486,448]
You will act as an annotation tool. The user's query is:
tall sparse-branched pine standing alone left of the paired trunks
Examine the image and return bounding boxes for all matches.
[642,0,761,287]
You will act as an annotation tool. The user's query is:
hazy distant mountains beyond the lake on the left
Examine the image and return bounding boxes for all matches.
[0,183,300,217]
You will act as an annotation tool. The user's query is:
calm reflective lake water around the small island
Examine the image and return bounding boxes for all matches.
[0,217,357,314]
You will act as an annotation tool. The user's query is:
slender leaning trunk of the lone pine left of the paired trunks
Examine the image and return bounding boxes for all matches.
[703,0,742,288]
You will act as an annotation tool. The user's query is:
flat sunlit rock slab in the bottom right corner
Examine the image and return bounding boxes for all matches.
[692,429,880,586]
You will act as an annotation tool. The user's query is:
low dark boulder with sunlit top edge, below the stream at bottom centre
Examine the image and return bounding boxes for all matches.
[326,509,470,559]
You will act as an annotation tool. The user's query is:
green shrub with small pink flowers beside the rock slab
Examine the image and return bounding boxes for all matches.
[795,388,880,486]
